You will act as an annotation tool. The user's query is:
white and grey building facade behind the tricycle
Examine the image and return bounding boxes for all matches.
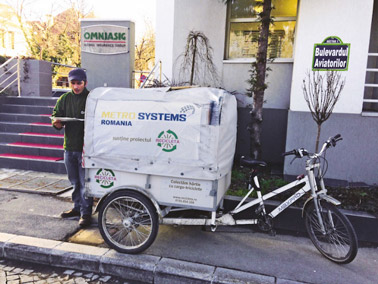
[156,0,378,184]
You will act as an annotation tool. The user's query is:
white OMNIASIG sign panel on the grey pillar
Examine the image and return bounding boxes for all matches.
[81,25,129,54]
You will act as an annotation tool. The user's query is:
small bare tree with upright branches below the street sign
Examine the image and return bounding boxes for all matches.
[302,71,345,152]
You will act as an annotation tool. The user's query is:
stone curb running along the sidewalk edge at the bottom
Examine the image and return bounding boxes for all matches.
[0,233,302,284]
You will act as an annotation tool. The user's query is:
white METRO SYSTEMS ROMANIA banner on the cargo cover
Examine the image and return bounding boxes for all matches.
[93,101,201,160]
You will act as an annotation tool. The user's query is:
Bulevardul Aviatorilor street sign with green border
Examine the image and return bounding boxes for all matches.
[312,36,350,71]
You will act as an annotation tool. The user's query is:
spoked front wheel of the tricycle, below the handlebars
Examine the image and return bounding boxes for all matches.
[306,200,358,264]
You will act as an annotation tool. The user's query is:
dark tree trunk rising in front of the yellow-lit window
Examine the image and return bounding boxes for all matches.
[250,0,272,159]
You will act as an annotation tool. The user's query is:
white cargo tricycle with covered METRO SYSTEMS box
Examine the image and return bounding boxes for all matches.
[83,88,357,263]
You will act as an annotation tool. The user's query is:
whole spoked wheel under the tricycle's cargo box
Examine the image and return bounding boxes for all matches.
[98,191,159,254]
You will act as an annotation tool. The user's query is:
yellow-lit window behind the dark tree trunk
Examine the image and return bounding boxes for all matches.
[226,0,298,59]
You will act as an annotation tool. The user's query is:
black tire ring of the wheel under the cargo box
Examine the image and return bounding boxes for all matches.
[98,190,159,254]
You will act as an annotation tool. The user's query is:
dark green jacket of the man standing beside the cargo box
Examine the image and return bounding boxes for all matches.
[52,88,89,152]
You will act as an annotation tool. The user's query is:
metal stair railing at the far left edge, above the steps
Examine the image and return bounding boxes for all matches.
[0,56,21,96]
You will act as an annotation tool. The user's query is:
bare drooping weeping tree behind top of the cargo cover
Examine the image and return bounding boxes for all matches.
[179,31,220,87]
